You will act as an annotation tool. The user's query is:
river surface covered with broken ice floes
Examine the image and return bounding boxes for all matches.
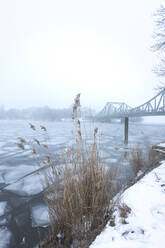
[0,120,165,248]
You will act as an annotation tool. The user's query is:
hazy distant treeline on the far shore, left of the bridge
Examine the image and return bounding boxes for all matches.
[0,106,95,121]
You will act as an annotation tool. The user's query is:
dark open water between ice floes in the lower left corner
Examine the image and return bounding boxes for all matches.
[0,191,48,248]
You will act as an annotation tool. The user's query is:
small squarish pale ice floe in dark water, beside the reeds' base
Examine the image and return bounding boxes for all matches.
[32,205,50,226]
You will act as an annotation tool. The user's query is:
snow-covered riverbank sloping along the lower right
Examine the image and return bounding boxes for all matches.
[90,161,165,248]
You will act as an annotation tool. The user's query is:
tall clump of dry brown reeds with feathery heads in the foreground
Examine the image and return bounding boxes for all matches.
[18,94,117,248]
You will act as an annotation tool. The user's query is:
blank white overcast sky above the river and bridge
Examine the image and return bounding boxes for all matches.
[0,0,164,109]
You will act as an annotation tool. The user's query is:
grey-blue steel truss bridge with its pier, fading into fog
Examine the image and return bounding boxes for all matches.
[96,89,165,144]
